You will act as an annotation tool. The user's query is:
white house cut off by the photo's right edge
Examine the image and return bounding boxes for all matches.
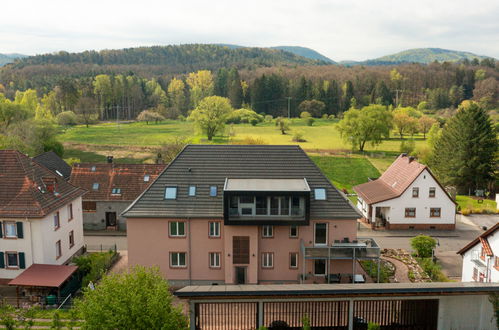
[457,222,499,282]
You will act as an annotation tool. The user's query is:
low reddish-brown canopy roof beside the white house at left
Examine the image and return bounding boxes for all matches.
[9,264,78,288]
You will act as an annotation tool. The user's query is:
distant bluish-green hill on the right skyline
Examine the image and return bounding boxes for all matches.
[360,48,494,65]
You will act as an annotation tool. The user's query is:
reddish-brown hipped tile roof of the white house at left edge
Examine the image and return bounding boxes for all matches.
[0,150,85,218]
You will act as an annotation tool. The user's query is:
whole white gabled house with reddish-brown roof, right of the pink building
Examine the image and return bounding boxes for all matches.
[353,154,456,230]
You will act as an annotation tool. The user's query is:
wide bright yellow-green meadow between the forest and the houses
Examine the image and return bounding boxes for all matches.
[59,119,425,152]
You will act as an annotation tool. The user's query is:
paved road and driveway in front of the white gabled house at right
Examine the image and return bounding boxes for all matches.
[358,215,492,280]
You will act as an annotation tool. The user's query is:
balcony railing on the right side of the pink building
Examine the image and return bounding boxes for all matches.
[301,238,381,260]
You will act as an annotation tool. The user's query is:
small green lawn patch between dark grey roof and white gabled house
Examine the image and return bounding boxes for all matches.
[310,156,380,193]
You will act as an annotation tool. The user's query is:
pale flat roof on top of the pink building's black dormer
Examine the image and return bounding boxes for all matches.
[224,178,310,192]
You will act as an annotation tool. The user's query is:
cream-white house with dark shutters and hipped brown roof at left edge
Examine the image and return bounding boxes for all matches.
[0,150,85,280]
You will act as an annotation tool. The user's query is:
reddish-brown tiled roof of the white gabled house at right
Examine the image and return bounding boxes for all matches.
[353,154,428,204]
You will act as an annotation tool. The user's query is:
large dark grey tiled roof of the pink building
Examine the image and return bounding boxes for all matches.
[124,145,360,219]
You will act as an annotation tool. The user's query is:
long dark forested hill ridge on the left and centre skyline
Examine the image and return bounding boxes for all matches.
[7,44,327,68]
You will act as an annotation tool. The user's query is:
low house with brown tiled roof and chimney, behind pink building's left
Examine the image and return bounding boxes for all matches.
[70,161,166,230]
